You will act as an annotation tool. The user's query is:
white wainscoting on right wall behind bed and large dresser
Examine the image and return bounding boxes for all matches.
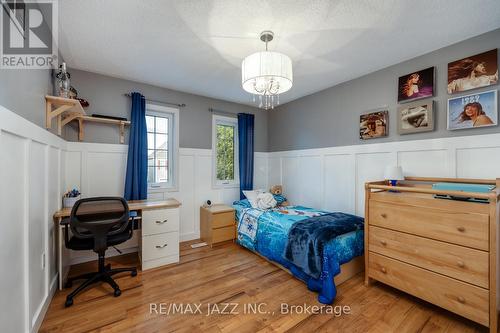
[268,134,500,216]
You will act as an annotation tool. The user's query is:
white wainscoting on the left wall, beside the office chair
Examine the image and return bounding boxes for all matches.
[0,106,66,332]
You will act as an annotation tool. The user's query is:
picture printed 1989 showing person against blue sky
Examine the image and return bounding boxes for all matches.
[447,90,498,130]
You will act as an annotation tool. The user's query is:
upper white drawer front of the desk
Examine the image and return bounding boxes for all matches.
[142,208,179,236]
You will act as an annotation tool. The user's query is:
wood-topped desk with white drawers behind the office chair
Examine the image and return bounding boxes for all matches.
[54,199,181,289]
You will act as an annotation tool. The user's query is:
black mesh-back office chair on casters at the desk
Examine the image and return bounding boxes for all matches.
[62,197,137,307]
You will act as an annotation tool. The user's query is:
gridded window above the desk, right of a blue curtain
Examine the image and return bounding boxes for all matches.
[146,104,178,188]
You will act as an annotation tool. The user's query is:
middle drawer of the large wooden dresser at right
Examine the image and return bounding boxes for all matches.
[368,226,489,288]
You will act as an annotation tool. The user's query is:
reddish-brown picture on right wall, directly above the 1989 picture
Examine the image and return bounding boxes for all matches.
[448,49,498,94]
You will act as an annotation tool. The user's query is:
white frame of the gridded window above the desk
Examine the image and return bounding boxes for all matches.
[146,103,179,193]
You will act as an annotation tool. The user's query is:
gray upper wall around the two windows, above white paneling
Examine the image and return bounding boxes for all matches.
[65,69,268,152]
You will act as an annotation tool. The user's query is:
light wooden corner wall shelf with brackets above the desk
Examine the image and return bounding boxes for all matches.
[45,96,130,143]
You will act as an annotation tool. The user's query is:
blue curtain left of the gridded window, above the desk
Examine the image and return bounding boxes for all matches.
[125,92,148,200]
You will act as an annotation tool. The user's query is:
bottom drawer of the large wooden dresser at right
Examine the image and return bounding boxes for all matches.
[368,252,489,326]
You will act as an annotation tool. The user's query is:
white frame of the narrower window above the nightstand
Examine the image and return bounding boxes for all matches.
[212,114,240,188]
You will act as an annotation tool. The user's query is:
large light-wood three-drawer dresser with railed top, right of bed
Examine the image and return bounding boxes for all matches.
[365,178,500,332]
